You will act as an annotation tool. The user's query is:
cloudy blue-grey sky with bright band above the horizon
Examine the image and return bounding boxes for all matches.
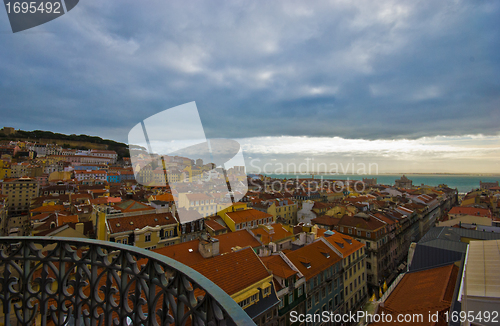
[0,0,500,173]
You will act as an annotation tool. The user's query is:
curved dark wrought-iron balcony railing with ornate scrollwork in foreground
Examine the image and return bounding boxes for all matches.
[0,237,255,326]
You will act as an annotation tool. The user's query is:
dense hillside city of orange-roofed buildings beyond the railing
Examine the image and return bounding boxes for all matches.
[0,127,500,325]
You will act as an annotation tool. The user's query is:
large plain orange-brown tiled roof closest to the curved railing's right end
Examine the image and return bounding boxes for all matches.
[191,248,270,295]
